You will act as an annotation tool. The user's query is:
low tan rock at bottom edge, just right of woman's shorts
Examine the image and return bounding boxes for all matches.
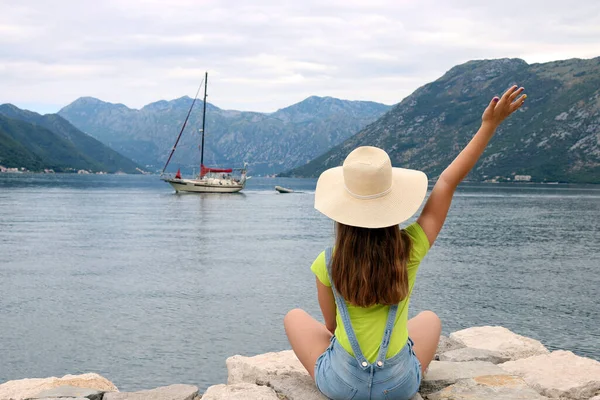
[427,375,547,400]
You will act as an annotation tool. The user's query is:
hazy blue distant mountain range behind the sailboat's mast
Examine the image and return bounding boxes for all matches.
[59,96,390,175]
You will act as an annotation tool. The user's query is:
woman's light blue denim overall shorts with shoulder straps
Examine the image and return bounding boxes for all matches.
[315,248,421,400]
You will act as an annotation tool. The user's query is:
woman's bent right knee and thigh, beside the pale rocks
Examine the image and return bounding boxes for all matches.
[408,311,442,374]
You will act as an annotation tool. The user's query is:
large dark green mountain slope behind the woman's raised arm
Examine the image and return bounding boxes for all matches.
[281,57,600,183]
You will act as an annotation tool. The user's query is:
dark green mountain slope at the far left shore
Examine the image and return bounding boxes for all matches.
[0,104,139,173]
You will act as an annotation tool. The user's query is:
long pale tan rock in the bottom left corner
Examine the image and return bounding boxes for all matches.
[0,373,118,400]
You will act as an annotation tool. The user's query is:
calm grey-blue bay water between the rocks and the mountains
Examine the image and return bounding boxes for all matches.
[0,175,600,390]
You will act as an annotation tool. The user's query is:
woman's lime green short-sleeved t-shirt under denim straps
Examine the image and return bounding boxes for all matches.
[311,222,429,363]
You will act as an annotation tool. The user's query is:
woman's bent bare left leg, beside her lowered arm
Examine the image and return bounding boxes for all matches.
[283,309,332,379]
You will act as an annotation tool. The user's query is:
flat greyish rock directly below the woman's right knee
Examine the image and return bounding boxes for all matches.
[419,361,509,396]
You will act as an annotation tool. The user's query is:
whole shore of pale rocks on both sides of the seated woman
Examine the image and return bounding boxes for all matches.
[0,326,600,400]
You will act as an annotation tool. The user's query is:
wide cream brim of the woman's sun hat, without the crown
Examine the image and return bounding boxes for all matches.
[315,167,427,228]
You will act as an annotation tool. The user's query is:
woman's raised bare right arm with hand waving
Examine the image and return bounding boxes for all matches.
[417,86,527,245]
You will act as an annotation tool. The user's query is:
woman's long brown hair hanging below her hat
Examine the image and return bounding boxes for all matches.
[331,222,411,307]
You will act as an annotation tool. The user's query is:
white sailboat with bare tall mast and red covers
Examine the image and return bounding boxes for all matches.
[161,72,247,193]
